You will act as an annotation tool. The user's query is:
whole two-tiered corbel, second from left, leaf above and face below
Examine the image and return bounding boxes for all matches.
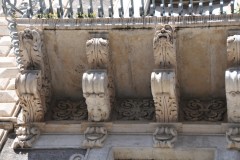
[82,38,115,121]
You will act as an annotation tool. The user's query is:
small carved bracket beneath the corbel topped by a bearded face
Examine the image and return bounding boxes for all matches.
[153,127,177,148]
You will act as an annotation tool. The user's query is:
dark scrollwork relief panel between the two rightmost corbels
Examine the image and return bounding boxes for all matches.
[182,99,227,121]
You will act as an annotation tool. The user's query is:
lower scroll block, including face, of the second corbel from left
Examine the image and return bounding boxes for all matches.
[82,70,111,121]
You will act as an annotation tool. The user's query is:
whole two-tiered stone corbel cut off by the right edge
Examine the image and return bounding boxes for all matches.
[225,35,240,123]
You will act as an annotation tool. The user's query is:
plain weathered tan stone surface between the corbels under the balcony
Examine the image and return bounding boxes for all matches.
[44,26,239,99]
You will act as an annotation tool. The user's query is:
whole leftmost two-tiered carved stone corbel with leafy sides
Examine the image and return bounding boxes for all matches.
[16,28,51,123]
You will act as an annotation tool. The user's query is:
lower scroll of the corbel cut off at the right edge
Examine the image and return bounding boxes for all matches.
[225,68,240,122]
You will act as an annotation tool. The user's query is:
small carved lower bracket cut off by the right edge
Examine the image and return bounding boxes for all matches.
[226,127,240,150]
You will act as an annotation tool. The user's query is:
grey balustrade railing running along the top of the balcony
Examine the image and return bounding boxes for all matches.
[2,0,240,18]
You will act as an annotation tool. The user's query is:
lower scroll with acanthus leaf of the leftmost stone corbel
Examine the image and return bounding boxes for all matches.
[16,70,46,123]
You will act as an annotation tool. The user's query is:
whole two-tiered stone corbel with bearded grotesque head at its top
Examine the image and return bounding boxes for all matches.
[151,25,178,122]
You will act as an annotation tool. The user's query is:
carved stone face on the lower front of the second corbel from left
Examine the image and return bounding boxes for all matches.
[86,97,110,122]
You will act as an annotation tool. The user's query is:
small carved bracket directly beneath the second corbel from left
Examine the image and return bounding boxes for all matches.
[82,126,107,148]
